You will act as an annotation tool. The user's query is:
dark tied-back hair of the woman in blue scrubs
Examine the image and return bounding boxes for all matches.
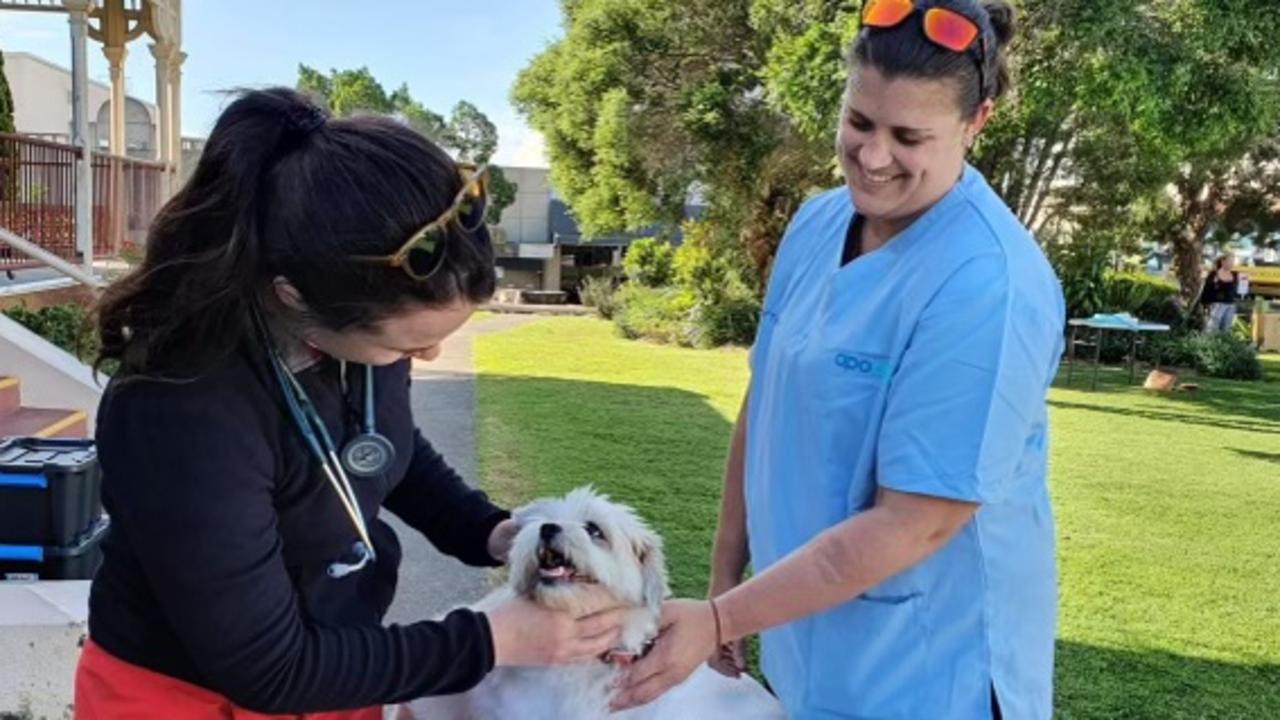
[849,0,1014,118]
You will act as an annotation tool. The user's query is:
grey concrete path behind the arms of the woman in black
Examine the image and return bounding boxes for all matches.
[383,315,534,624]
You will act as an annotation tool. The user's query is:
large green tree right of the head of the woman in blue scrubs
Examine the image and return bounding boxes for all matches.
[962,0,1280,301]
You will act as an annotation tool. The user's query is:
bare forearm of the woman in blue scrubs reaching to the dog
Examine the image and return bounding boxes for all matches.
[717,493,977,642]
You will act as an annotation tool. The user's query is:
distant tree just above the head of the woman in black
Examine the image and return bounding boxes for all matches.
[297,64,517,225]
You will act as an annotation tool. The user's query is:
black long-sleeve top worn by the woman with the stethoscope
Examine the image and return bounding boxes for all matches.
[90,348,508,714]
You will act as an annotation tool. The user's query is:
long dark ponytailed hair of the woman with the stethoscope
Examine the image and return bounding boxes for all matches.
[96,87,495,378]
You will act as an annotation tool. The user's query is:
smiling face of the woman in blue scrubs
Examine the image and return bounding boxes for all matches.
[836,64,992,229]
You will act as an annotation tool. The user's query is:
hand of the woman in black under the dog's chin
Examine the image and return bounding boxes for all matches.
[485,597,627,666]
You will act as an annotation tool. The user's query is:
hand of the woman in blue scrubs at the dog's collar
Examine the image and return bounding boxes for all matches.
[609,600,717,711]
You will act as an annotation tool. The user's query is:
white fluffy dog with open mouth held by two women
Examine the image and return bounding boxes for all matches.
[402,488,786,720]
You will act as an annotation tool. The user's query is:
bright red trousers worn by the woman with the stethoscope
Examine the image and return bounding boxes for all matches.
[76,632,383,720]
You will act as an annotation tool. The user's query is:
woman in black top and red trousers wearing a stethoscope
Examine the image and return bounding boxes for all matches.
[77,88,620,719]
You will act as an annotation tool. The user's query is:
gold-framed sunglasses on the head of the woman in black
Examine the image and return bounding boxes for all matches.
[351,163,489,281]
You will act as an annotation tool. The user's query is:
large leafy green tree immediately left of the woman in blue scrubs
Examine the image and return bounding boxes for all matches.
[513,0,838,287]
